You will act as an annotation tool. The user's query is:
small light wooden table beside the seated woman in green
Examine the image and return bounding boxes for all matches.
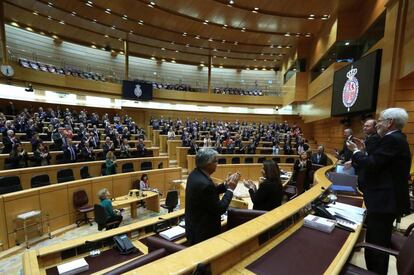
[112,191,160,218]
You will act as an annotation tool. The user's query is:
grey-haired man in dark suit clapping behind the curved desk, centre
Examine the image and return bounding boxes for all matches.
[185,148,240,245]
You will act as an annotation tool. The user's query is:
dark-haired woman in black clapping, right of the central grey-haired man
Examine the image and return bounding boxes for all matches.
[244,160,283,211]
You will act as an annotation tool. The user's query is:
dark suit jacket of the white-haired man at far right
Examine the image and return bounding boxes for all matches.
[352,131,411,215]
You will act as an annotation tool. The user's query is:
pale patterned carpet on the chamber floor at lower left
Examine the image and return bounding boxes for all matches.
[0,207,167,275]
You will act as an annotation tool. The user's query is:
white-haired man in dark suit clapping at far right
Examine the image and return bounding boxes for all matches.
[347,108,411,274]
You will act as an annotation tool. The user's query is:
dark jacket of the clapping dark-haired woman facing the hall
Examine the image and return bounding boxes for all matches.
[249,180,283,211]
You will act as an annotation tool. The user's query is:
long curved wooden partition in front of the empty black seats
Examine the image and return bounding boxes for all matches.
[0,168,181,249]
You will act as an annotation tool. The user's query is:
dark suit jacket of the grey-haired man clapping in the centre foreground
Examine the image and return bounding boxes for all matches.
[185,168,233,245]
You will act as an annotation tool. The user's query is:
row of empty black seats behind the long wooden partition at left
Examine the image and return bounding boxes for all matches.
[0,161,156,195]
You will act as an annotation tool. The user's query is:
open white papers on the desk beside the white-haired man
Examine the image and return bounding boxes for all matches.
[326,202,366,230]
